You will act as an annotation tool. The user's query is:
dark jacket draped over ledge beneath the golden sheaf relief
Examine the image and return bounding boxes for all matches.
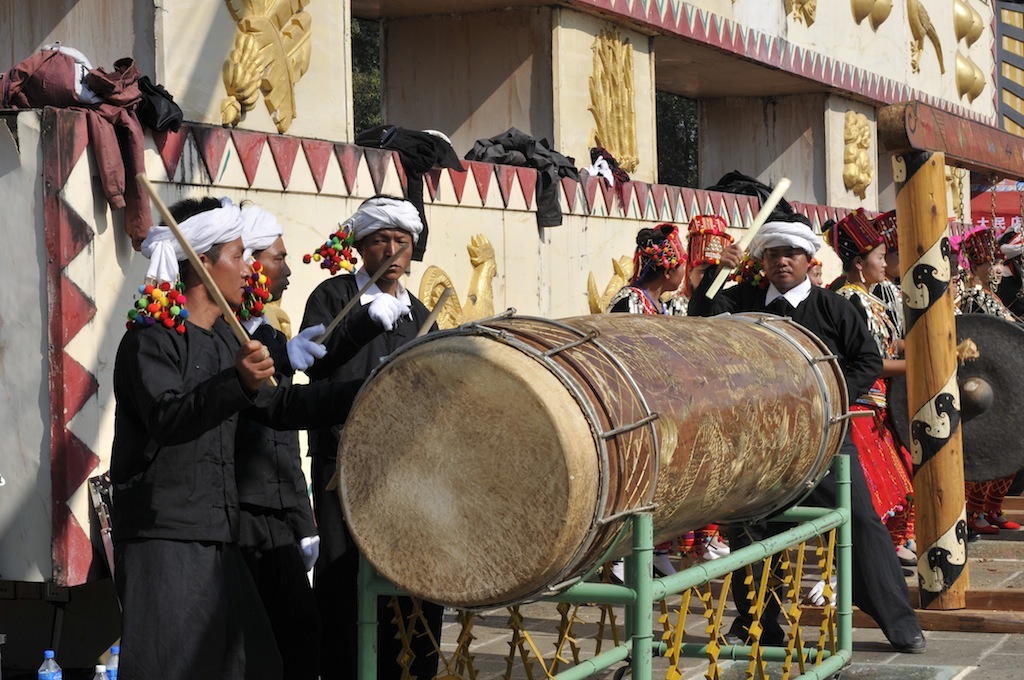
[465,128,580,226]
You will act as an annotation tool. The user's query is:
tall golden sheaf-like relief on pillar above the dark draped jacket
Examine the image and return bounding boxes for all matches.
[587,30,640,172]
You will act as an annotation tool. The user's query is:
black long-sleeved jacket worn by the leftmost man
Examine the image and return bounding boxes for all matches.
[111,318,354,542]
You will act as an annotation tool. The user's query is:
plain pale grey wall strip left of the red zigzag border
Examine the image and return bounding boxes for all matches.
[0,115,51,581]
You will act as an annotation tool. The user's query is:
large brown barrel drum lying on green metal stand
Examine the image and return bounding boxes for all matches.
[338,314,848,607]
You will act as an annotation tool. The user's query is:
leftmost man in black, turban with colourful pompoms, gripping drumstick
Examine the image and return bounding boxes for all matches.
[111,193,362,680]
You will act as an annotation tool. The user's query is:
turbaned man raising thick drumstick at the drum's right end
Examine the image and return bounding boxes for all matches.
[688,213,926,653]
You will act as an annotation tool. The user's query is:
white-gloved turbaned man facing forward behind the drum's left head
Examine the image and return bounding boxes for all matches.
[302,197,443,680]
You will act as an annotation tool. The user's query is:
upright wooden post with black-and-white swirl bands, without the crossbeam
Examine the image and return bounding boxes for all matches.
[893,152,968,609]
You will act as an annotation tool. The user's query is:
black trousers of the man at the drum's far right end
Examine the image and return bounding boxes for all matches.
[727,434,921,647]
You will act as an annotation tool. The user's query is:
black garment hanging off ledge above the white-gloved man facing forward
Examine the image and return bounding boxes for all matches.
[355,125,466,261]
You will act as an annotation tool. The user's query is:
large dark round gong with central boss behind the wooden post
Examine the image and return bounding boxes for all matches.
[889,314,1024,481]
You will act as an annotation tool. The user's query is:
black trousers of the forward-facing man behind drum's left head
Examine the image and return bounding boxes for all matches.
[312,459,444,680]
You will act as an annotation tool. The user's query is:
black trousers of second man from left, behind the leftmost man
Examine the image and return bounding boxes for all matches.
[240,505,321,680]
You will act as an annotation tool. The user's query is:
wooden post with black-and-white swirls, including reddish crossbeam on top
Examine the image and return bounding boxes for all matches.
[878,101,1024,609]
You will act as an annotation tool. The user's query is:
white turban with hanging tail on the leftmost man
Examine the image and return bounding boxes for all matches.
[142,198,242,284]
